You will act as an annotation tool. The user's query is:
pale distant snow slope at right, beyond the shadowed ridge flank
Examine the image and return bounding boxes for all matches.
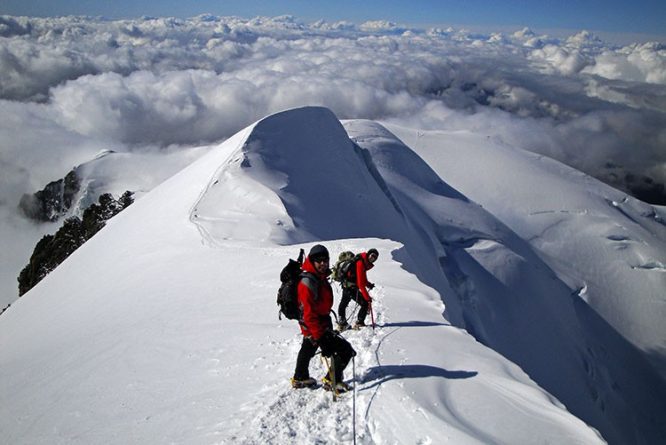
[390,126,666,370]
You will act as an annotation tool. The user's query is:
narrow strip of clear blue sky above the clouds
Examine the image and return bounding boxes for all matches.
[0,0,666,35]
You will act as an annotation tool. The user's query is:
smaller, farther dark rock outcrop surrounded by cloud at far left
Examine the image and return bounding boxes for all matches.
[19,170,81,222]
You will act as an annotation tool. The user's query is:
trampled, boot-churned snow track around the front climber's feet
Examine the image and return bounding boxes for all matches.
[221,286,395,445]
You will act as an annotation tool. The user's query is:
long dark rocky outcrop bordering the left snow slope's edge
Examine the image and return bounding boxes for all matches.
[18,191,134,296]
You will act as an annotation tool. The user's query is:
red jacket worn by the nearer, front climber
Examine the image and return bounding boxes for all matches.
[297,258,333,340]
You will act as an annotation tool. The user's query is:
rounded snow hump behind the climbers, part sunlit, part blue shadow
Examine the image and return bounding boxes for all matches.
[194,108,404,243]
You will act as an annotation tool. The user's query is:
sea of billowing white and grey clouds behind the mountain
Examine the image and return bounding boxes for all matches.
[0,15,666,294]
